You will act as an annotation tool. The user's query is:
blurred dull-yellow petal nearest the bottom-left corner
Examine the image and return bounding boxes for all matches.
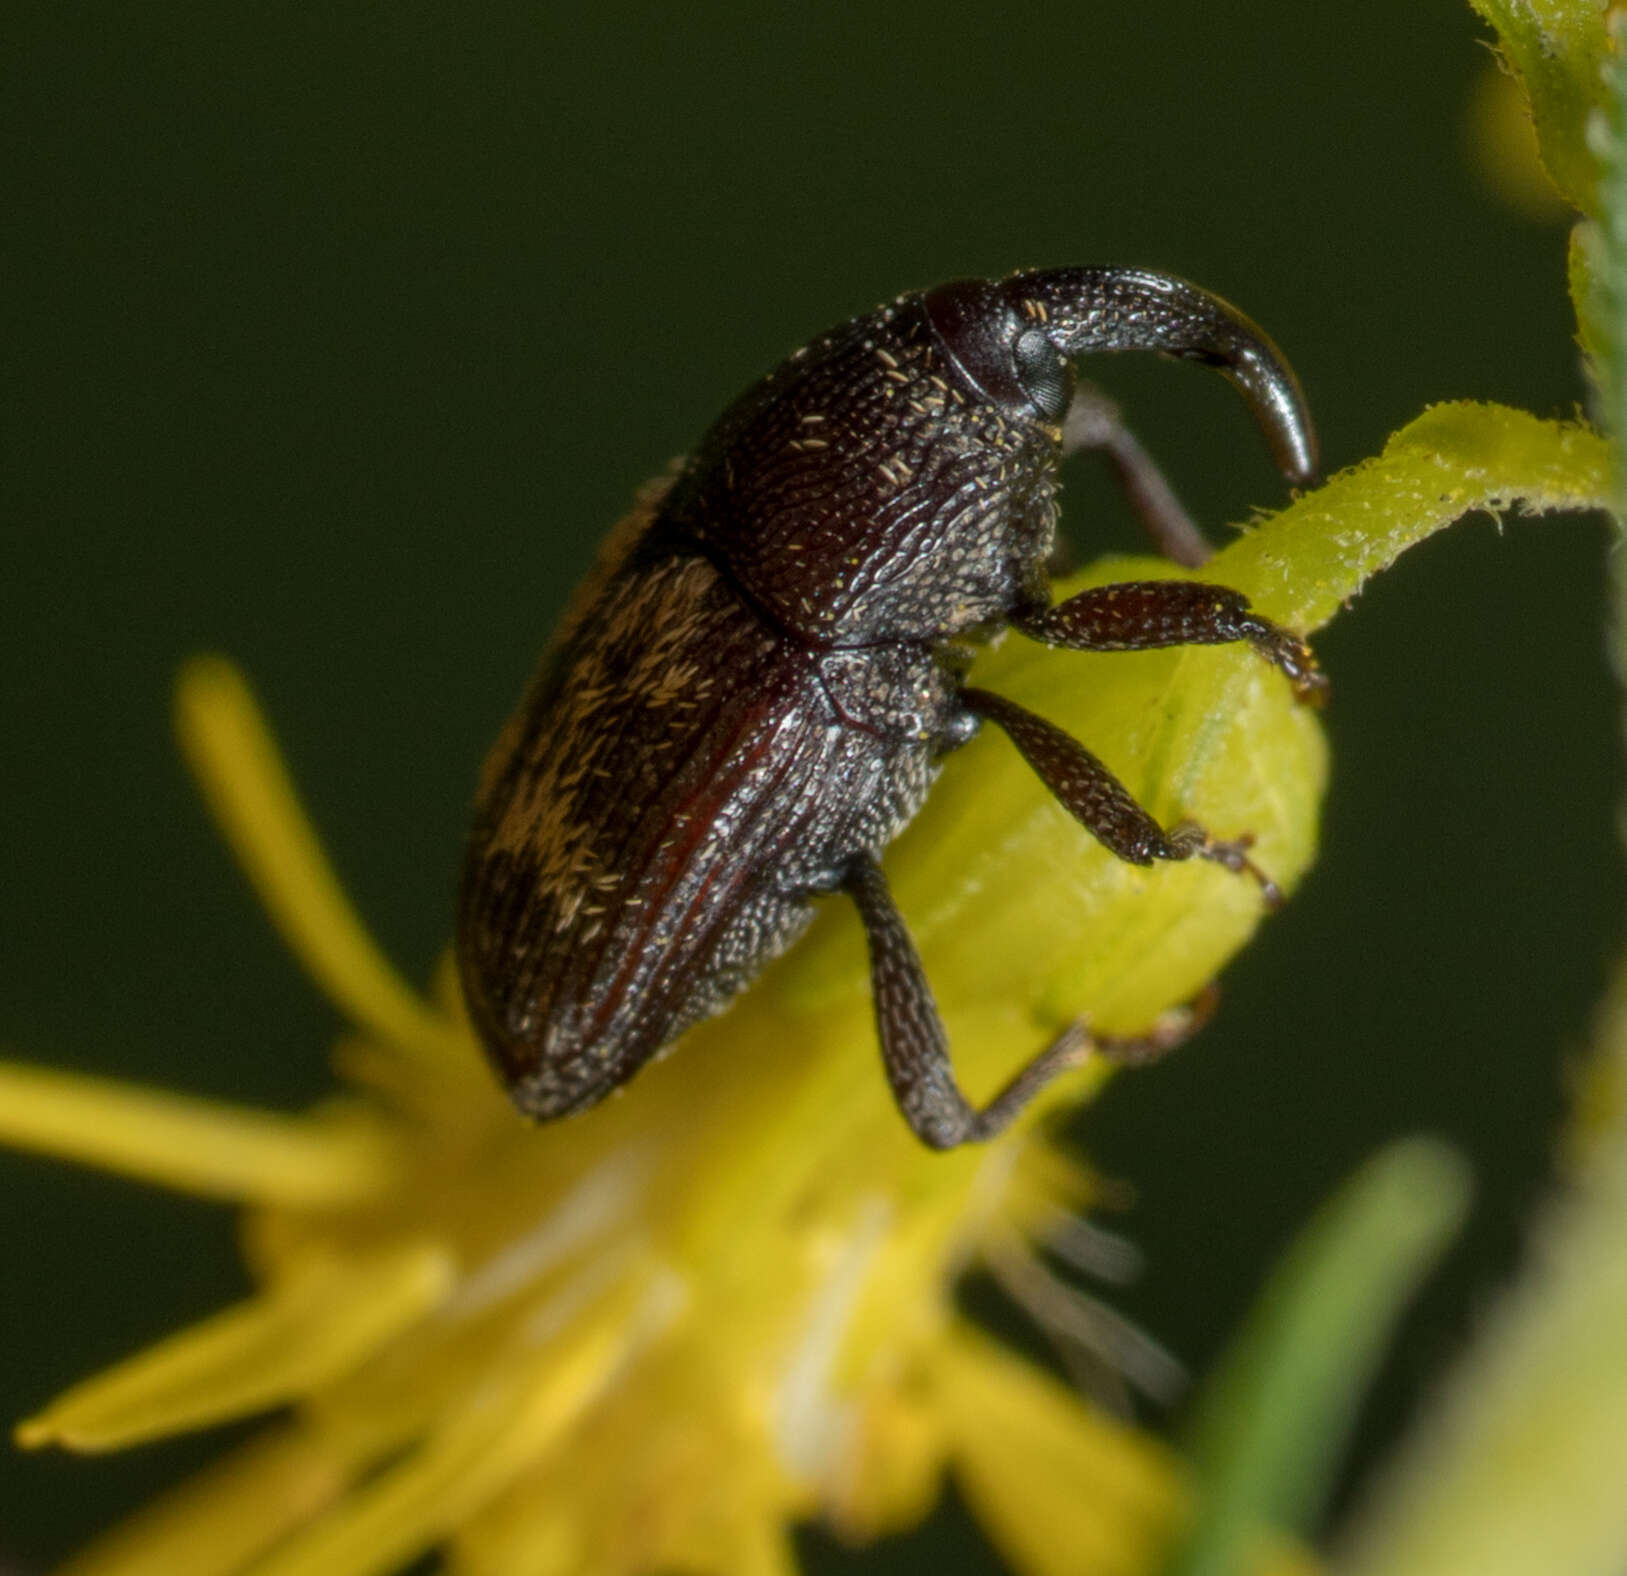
[57,1425,362,1576]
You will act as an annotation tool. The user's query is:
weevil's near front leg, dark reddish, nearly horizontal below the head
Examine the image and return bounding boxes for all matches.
[1012,581,1328,706]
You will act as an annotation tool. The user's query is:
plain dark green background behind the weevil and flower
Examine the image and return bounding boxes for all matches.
[0,0,1622,1569]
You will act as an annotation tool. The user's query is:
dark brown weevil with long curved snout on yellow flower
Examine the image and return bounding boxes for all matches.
[457,267,1324,1148]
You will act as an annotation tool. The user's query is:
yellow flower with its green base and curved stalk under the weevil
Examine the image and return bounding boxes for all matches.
[0,407,1603,1576]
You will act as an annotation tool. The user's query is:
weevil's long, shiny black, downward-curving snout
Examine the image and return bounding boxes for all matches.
[1002,268,1318,486]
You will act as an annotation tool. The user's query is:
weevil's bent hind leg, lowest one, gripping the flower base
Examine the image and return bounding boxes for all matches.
[843,854,1215,1150]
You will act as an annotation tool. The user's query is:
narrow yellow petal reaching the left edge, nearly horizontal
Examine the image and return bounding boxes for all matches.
[0,1062,395,1208]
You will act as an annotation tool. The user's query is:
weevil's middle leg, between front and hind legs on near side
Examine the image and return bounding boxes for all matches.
[960,686,1282,908]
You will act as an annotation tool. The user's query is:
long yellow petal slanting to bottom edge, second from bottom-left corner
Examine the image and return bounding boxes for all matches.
[240,1282,672,1576]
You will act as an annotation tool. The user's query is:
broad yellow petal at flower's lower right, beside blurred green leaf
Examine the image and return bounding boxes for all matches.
[939,1326,1186,1576]
